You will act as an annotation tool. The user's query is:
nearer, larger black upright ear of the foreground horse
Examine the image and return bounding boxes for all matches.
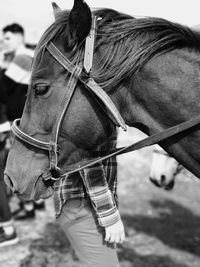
[67,0,92,47]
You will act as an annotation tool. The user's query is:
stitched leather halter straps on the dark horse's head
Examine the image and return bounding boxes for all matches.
[11,17,126,179]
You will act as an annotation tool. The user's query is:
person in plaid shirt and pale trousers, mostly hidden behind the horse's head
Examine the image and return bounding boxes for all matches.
[54,137,125,267]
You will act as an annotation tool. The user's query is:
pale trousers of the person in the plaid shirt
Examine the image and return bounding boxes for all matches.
[57,198,119,267]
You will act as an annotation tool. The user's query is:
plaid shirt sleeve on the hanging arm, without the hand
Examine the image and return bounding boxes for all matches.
[80,163,121,227]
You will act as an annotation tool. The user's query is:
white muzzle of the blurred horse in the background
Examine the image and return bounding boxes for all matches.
[149,145,182,190]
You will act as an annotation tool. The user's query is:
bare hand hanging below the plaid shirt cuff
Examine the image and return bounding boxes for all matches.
[105,220,125,244]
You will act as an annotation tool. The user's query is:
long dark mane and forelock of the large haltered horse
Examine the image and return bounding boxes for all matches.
[33,9,200,90]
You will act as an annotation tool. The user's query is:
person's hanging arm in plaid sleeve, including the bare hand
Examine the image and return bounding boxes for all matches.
[81,163,125,243]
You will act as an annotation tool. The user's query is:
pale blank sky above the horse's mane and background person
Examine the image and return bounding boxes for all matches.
[0,0,200,43]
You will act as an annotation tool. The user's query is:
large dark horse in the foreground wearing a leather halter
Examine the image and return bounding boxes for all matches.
[4,0,200,200]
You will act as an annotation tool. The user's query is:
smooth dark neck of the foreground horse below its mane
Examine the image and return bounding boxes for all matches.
[114,50,200,177]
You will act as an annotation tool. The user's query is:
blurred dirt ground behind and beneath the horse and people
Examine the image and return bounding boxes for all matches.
[0,129,200,267]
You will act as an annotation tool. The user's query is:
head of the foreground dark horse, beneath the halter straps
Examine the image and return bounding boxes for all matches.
[5,0,115,199]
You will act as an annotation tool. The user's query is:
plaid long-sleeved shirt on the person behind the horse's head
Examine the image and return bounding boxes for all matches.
[54,140,120,227]
